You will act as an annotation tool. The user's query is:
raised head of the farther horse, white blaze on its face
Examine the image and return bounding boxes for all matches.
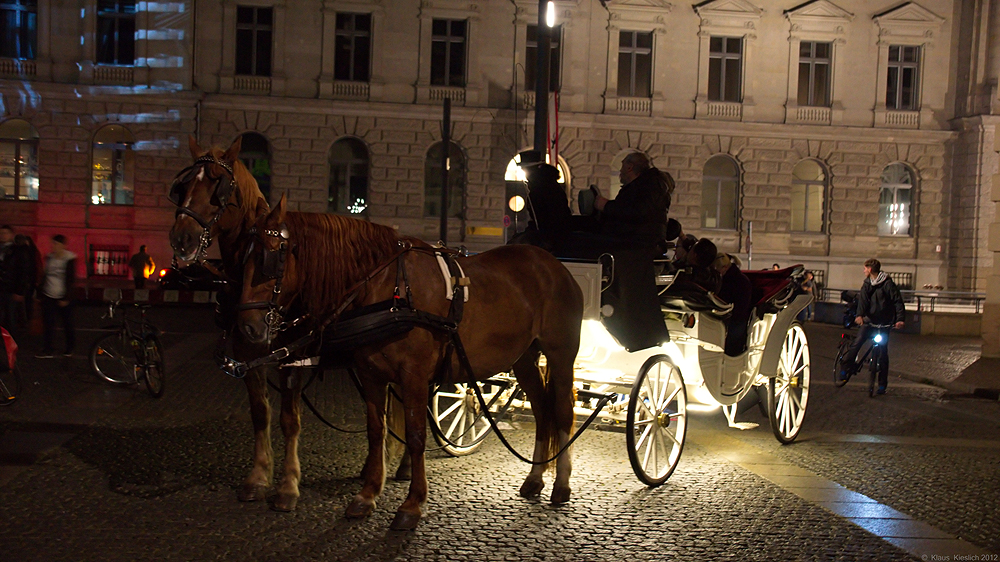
[169,137,267,260]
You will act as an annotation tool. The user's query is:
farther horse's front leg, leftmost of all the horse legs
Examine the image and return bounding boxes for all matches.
[237,367,274,502]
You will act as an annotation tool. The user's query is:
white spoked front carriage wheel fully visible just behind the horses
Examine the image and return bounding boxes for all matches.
[625,355,687,486]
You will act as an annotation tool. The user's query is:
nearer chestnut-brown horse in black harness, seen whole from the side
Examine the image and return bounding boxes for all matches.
[239,197,583,529]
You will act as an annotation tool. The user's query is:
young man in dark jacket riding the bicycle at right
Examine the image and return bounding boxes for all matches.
[840,258,906,394]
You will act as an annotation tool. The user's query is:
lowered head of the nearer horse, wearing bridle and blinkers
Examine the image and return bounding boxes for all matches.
[237,195,299,344]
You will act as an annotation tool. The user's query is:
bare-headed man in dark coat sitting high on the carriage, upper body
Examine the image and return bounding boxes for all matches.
[594,152,674,245]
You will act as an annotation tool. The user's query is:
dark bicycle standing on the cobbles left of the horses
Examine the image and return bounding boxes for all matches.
[90,294,165,398]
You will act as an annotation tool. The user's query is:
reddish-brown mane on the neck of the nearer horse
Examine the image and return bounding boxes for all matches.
[285,213,399,318]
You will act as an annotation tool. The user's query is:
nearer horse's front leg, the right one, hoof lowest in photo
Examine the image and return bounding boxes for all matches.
[389,370,428,531]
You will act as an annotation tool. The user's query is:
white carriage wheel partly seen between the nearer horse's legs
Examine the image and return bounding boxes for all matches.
[430,383,501,457]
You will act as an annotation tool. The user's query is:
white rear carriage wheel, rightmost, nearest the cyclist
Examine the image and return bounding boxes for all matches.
[767,322,809,443]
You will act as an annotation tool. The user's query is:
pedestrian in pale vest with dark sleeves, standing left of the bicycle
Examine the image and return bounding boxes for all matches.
[35,234,76,359]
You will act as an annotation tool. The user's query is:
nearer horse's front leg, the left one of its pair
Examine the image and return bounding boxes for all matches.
[345,375,387,519]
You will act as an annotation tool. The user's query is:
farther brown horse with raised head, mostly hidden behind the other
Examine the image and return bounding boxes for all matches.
[170,138,410,511]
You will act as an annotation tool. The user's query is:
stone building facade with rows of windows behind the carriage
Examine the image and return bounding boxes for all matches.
[0,0,1000,298]
